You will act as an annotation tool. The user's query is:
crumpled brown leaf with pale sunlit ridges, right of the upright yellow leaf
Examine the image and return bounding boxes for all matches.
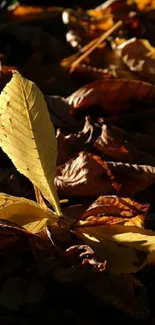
[55,152,118,197]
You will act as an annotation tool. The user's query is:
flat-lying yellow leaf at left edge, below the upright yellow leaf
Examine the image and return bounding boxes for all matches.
[0,193,56,233]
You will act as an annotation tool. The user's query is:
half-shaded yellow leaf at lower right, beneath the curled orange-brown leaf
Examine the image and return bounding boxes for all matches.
[75,225,155,274]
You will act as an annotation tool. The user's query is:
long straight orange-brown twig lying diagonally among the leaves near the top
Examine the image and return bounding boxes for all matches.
[70,20,122,72]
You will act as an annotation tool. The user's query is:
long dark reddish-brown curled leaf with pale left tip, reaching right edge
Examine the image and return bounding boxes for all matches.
[67,79,155,115]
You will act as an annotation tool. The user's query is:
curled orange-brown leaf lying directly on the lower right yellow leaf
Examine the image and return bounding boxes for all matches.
[74,195,149,227]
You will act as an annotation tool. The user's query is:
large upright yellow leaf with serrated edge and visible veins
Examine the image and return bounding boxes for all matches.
[0,71,61,215]
